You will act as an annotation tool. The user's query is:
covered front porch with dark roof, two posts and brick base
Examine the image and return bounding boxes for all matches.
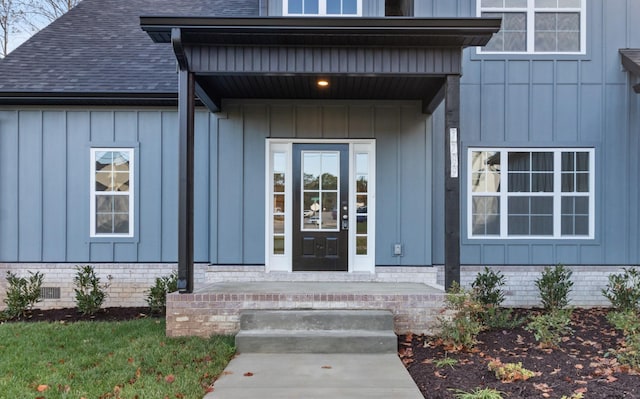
[141,17,501,336]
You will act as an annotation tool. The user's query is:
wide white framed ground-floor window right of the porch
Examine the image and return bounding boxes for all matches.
[467,148,595,239]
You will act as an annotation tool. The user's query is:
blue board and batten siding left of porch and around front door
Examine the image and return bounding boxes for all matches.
[0,101,432,265]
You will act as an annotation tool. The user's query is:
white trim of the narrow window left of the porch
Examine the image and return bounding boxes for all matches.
[89,147,135,238]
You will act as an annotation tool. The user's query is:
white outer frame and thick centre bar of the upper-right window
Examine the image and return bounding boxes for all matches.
[476,0,587,55]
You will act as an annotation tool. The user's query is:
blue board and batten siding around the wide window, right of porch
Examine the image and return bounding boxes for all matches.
[422,0,640,265]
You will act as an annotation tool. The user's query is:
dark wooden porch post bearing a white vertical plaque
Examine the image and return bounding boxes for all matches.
[444,75,460,290]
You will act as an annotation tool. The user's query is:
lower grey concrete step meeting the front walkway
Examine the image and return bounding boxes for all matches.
[236,329,398,353]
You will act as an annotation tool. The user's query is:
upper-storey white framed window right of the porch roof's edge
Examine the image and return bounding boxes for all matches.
[476,0,586,54]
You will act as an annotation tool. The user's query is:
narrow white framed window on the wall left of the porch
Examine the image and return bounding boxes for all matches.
[89,148,134,237]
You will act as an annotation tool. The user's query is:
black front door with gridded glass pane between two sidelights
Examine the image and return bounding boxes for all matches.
[292,144,349,271]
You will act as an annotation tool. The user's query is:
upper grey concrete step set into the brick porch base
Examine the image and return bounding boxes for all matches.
[240,310,393,331]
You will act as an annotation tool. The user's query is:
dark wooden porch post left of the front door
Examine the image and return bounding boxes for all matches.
[178,68,195,293]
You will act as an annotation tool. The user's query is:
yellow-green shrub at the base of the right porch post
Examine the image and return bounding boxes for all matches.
[438,283,484,350]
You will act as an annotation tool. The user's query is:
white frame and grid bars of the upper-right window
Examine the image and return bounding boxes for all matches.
[477,0,586,54]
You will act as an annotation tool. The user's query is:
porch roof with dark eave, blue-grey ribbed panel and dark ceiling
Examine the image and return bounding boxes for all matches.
[140,17,500,112]
